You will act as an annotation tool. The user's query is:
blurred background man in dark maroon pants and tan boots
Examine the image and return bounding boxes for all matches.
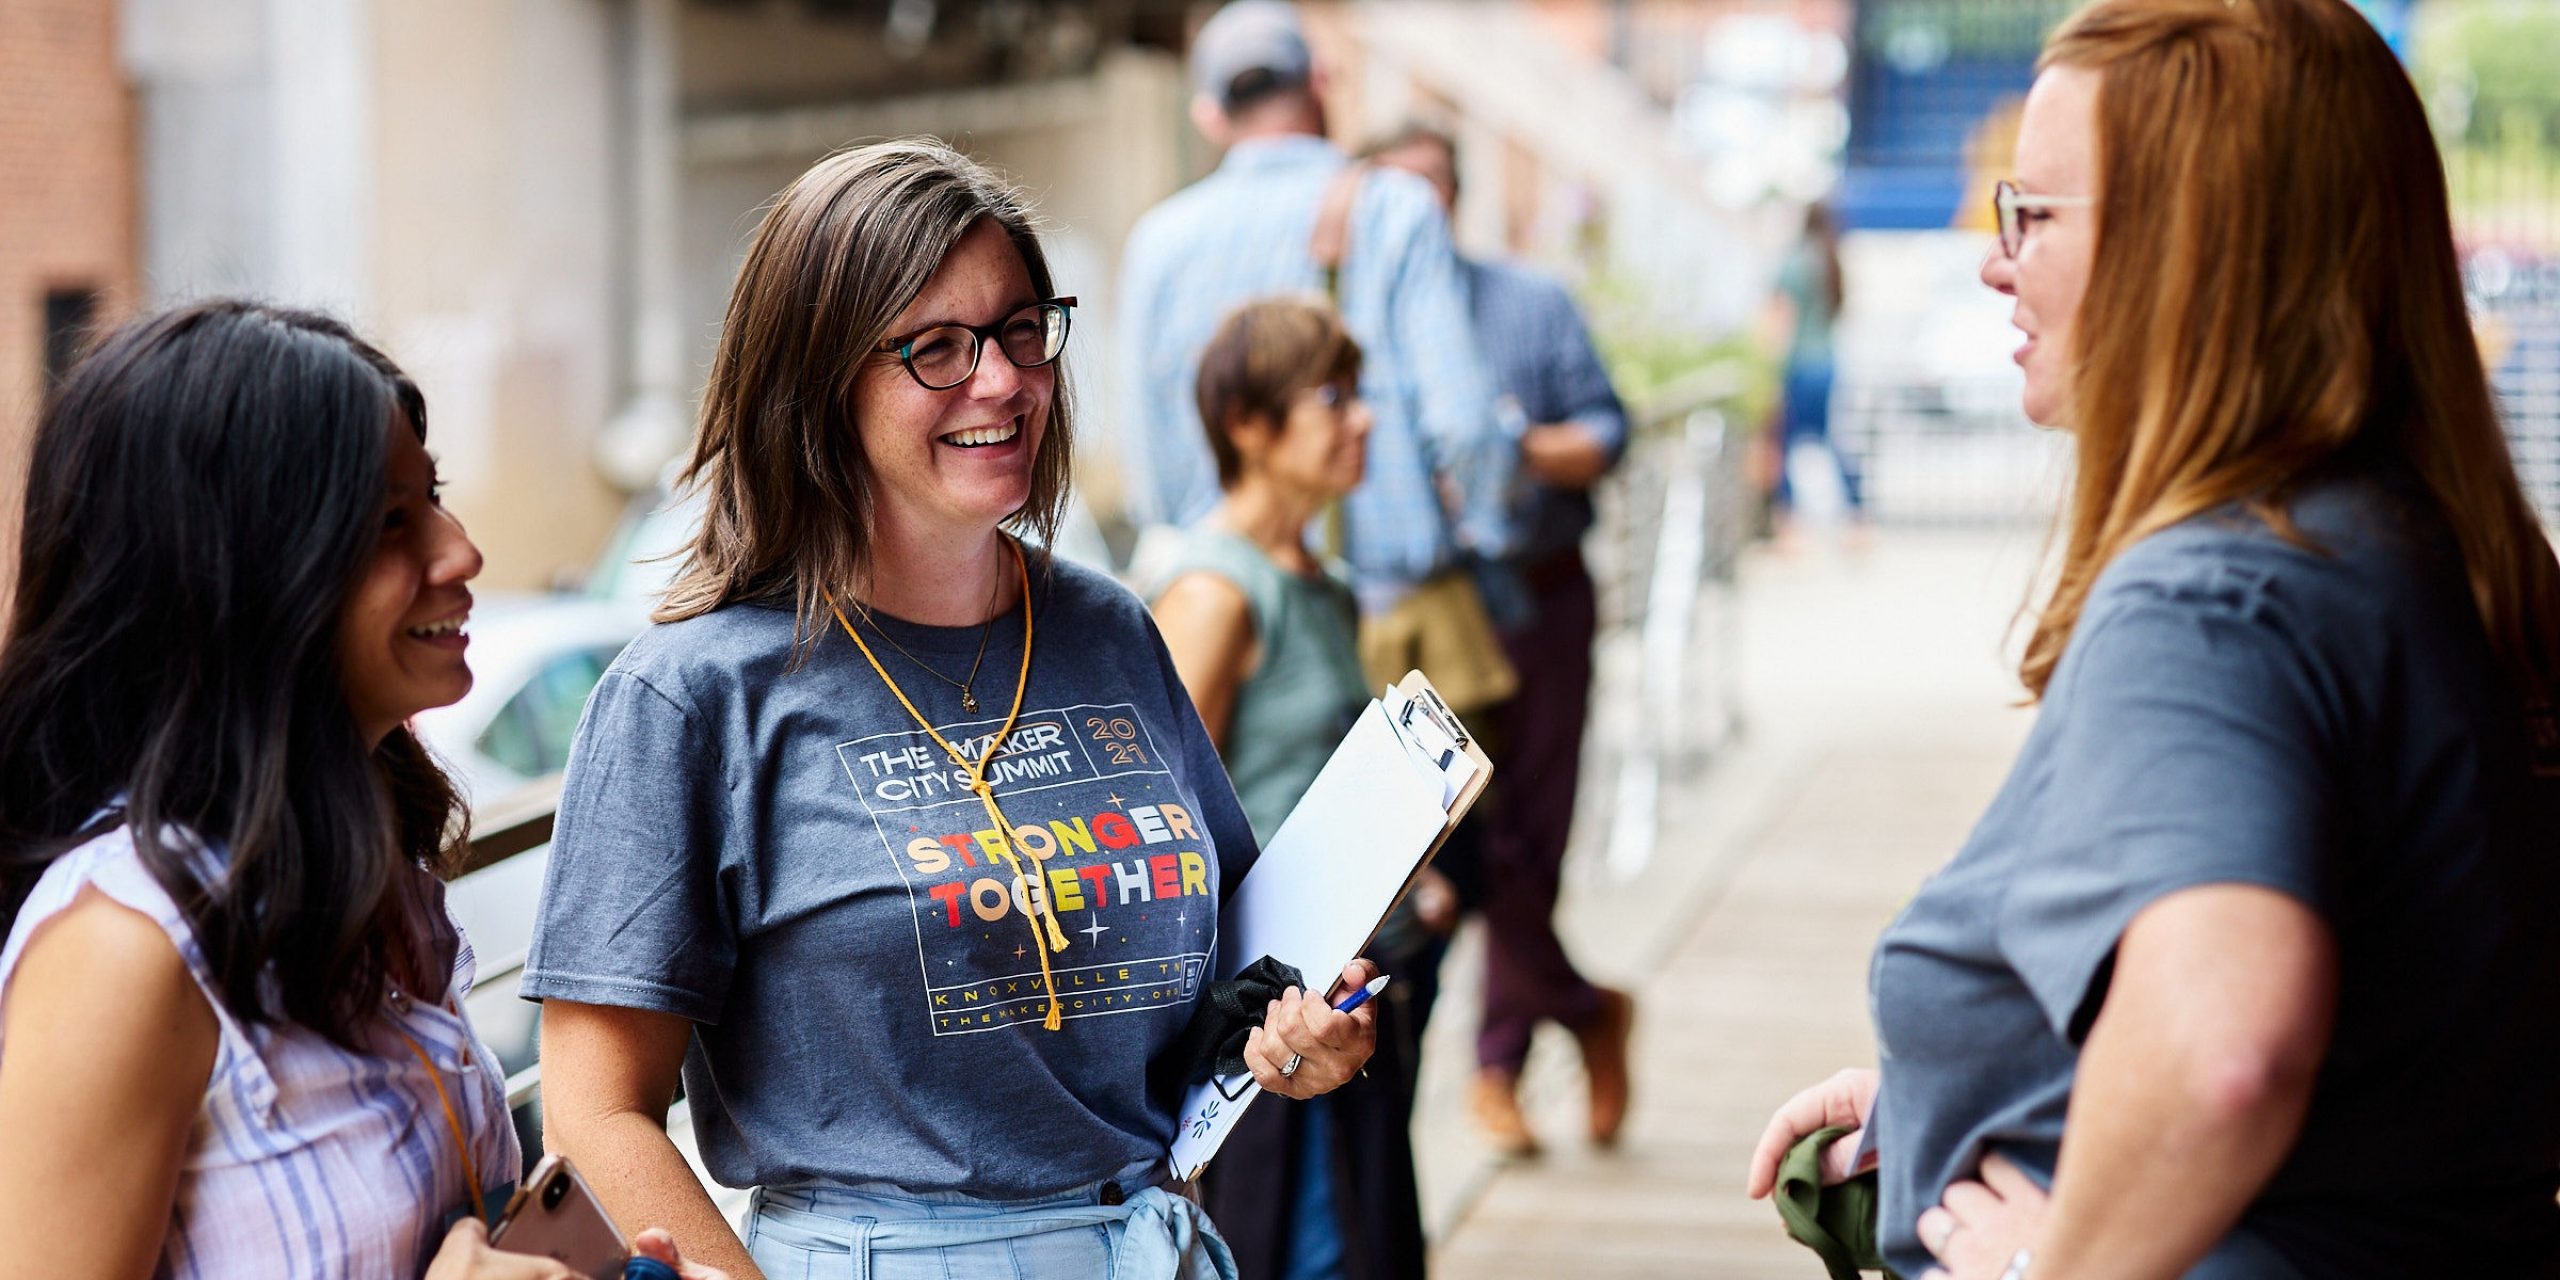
[1370,125,1636,1155]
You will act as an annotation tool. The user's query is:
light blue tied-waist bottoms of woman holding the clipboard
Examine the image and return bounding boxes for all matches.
[748,1183,1236,1280]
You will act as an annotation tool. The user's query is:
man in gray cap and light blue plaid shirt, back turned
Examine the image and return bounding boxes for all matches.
[1116,0,1518,614]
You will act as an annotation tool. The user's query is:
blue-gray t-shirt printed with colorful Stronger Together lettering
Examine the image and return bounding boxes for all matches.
[522,561,1254,1198]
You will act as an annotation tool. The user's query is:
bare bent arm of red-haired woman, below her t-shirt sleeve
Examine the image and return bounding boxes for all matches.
[2030,886,2337,1280]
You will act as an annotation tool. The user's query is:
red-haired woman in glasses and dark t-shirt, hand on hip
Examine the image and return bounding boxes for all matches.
[1751,0,2560,1280]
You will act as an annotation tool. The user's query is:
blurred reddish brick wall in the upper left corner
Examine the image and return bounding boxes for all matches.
[0,0,136,581]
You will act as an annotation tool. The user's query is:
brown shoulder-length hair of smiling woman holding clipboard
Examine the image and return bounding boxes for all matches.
[655,138,1075,645]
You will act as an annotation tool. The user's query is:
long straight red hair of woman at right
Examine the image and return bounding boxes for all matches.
[2020,0,2560,704]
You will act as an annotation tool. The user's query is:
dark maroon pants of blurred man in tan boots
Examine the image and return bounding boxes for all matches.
[1475,550,1600,1073]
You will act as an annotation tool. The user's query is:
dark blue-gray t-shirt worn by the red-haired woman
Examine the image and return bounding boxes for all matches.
[1869,466,2560,1277]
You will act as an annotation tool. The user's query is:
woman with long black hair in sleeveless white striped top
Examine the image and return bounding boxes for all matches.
[0,302,714,1280]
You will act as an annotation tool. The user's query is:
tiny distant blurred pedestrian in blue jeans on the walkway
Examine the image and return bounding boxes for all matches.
[1766,202,1866,548]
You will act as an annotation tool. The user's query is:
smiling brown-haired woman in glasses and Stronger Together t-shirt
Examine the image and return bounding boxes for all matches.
[525,143,1375,1280]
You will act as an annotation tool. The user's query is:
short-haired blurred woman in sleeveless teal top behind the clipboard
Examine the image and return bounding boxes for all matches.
[1155,300,1428,1280]
